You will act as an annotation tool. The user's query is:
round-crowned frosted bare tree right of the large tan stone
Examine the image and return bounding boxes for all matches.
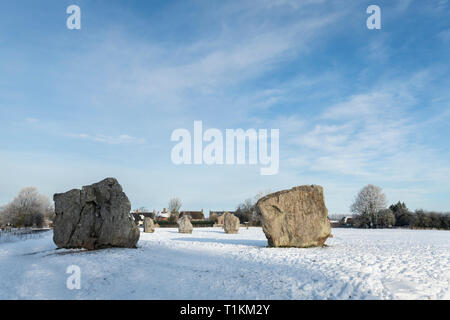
[350,184,387,227]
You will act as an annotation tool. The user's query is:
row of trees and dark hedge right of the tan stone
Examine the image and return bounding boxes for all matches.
[350,184,450,230]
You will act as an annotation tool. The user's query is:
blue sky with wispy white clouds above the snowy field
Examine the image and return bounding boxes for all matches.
[0,0,450,213]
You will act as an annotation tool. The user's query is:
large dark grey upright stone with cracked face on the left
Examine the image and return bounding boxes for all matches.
[53,178,139,250]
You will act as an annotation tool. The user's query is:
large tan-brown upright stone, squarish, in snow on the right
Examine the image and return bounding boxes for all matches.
[256,185,331,248]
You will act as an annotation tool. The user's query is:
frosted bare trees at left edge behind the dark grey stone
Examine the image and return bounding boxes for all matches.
[0,187,54,228]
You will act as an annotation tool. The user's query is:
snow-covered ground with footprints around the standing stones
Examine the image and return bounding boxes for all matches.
[0,228,450,299]
